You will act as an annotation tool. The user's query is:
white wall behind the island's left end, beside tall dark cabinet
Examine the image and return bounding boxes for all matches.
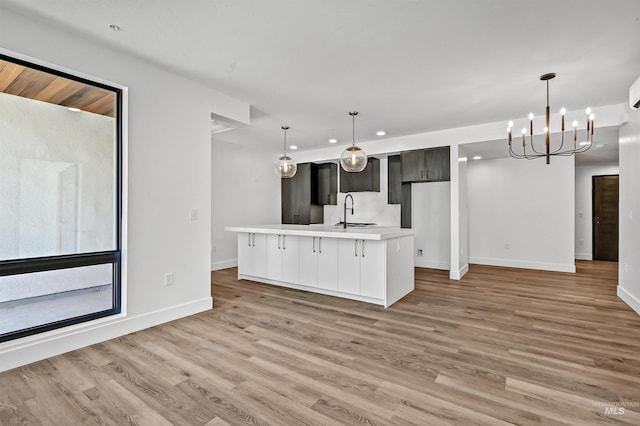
[211,141,281,270]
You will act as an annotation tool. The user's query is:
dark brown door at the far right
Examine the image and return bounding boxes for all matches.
[593,175,618,262]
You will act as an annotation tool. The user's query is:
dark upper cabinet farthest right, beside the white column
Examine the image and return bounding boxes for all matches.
[400,146,450,182]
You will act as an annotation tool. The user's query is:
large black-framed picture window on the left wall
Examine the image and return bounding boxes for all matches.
[0,54,122,341]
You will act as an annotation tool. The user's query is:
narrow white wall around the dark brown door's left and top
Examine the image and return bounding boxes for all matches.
[575,164,620,260]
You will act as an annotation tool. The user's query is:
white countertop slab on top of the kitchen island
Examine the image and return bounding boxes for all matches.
[224,225,415,240]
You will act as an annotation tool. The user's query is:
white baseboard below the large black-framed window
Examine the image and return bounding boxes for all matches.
[0,297,213,372]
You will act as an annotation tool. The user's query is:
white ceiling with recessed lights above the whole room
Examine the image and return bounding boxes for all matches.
[0,0,640,157]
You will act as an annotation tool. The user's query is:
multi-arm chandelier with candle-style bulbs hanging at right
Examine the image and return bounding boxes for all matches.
[507,72,595,164]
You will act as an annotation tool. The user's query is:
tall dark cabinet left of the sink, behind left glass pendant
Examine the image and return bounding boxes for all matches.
[280,163,324,225]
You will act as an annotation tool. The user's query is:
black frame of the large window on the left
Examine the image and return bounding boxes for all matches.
[0,50,124,343]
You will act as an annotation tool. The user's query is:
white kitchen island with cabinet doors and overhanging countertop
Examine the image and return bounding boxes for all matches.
[225,225,414,307]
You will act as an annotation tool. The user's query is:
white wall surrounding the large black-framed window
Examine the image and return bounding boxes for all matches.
[0,10,248,370]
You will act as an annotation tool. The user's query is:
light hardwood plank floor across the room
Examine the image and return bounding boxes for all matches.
[0,261,640,426]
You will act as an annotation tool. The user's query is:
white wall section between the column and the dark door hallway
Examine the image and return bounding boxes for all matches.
[467,157,575,272]
